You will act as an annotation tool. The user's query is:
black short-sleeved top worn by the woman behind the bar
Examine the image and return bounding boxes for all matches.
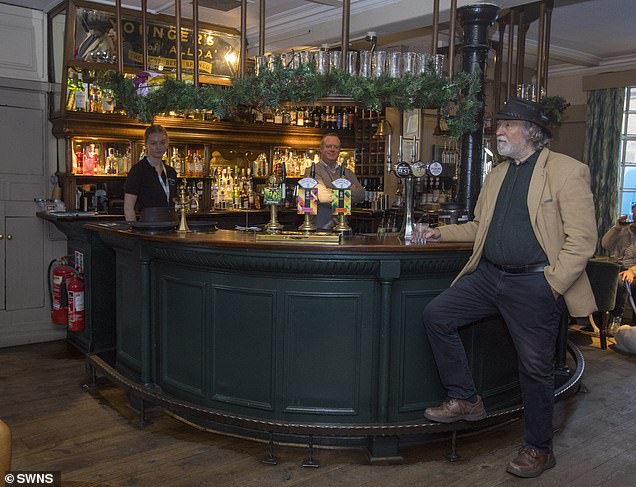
[124,157,177,211]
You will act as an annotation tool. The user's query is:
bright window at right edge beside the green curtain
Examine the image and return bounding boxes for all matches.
[618,86,636,215]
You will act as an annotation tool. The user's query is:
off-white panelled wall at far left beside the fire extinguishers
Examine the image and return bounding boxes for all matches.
[0,4,66,347]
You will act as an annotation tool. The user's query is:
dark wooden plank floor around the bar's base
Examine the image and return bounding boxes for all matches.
[0,334,636,487]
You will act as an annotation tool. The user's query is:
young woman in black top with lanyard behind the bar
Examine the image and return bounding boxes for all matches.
[124,125,177,221]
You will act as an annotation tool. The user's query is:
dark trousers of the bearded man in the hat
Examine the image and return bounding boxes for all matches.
[424,260,564,450]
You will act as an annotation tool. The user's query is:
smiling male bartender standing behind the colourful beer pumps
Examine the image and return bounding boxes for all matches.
[305,134,364,230]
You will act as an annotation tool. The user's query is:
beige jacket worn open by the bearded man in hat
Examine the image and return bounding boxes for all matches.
[440,148,598,316]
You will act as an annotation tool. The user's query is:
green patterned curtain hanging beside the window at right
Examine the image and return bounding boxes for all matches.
[583,88,625,253]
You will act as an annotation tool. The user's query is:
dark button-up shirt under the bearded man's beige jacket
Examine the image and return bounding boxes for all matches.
[484,152,548,265]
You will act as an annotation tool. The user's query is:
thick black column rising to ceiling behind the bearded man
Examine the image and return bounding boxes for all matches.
[457,3,499,217]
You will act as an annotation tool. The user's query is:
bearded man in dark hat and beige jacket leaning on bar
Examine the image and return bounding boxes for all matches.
[424,98,597,477]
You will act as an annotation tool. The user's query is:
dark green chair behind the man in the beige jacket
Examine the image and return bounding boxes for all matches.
[585,259,620,350]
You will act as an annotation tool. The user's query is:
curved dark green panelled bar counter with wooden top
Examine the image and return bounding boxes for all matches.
[87,222,583,460]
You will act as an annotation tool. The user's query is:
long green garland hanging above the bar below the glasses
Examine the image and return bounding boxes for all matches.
[106,63,483,137]
